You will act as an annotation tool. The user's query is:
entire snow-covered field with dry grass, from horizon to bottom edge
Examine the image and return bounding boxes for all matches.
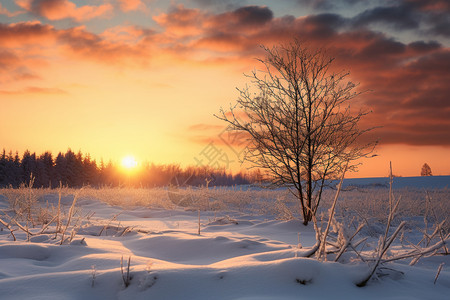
[0,177,450,300]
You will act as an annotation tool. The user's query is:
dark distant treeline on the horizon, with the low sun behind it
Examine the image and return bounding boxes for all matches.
[0,149,262,188]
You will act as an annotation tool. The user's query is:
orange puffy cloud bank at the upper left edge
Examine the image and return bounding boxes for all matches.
[0,21,156,84]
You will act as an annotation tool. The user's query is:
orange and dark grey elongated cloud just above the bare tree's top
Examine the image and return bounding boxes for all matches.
[154,5,347,56]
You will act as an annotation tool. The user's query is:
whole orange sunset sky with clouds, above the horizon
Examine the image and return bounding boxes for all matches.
[0,0,450,177]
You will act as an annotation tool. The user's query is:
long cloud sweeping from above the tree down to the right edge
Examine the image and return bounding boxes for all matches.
[153,3,450,145]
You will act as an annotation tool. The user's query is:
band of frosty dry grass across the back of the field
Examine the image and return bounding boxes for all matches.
[0,186,450,239]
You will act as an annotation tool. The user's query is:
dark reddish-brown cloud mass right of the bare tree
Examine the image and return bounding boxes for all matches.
[357,48,450,145]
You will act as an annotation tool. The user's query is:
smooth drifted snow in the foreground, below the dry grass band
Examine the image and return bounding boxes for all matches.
[0,182,450,300]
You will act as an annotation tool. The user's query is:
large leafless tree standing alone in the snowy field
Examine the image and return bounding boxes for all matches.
[216,40,375,225]
